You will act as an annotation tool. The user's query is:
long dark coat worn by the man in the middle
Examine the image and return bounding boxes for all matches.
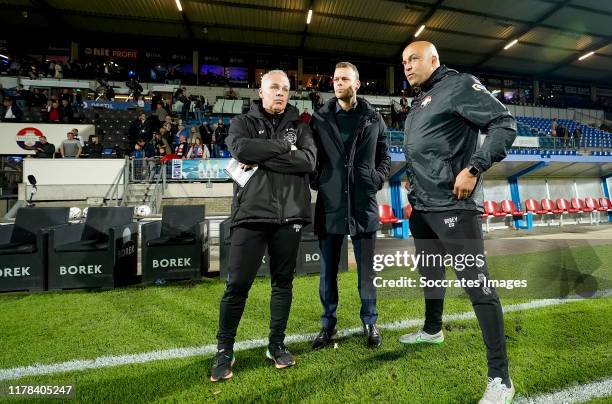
[310,97,391,236]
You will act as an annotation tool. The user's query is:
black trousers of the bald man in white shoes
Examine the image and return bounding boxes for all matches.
[409,210,508,380]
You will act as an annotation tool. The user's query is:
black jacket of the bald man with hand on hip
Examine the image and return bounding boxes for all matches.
[404,66,516,212]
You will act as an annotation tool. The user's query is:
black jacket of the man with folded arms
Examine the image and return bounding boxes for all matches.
[226,101,317,227]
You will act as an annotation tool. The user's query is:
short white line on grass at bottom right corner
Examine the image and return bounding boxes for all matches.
[514,378,612,404]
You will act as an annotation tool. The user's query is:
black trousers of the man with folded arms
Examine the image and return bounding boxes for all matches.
[217,223,302,349]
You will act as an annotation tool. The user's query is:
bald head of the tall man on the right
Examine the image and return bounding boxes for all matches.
[402,41,440,87]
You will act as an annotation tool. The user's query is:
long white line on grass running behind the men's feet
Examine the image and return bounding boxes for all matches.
[0,289,612,381]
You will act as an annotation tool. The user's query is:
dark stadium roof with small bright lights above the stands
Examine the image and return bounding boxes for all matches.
[0,0,612,82]
